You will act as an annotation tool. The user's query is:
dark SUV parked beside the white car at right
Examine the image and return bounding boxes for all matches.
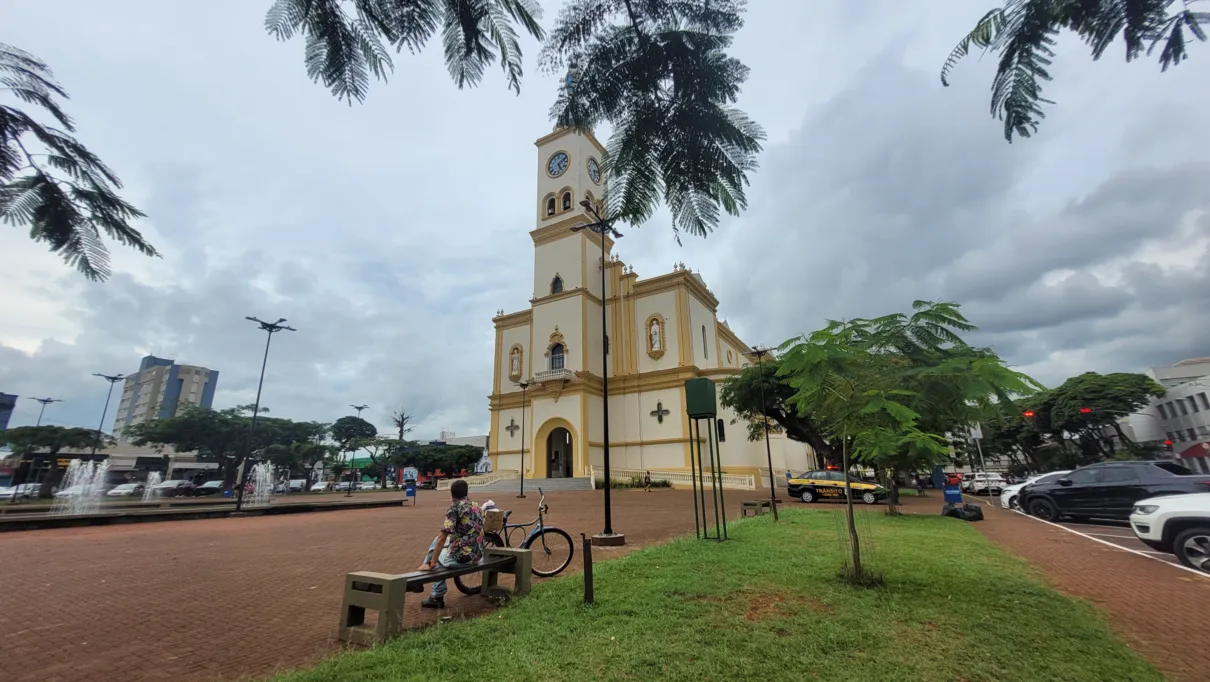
[1020,460,1210,521]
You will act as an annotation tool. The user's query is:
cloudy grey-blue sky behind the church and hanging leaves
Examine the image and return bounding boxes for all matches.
[0,0,1210,438]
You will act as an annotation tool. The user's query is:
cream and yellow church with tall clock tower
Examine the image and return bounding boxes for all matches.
[488,128,816,487]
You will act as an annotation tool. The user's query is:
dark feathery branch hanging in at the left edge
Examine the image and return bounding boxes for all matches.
[0,44,160,282]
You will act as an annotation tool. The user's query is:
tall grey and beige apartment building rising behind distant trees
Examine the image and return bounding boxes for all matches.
[114,356,219,440]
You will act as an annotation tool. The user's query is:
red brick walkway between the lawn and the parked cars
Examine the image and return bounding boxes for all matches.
[905,495,1210,682]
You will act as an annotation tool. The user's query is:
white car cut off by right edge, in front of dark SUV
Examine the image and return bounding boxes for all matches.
[1130,492,1210,574]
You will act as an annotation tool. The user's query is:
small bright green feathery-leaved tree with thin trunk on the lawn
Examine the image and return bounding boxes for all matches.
[778,301,1041,584]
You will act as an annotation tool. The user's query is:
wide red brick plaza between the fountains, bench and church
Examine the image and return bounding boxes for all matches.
[0,490,738,682]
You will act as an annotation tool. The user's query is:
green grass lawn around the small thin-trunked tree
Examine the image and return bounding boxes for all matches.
[277,509,1163,682]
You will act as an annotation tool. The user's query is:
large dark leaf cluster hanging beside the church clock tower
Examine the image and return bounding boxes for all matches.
[541,0,765,241]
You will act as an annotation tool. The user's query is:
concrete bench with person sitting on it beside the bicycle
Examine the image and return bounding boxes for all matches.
[338,547,534,646]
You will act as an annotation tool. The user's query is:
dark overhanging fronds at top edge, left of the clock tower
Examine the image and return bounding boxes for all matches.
[265,0,543,104]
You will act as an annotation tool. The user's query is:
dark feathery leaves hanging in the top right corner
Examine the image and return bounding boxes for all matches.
[941,0,1210,141]
